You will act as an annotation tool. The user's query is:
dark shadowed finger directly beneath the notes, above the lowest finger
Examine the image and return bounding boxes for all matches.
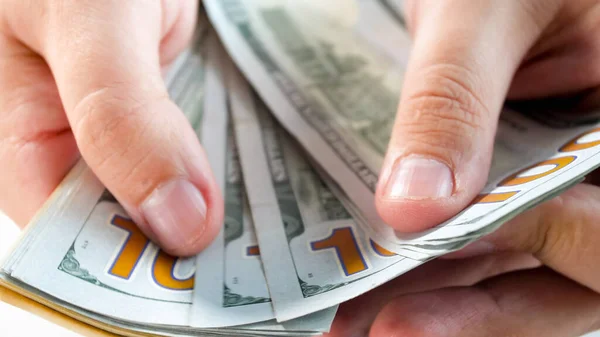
[327,254,539,337]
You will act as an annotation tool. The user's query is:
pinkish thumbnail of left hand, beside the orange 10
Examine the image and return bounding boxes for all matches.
[141,179,206,249]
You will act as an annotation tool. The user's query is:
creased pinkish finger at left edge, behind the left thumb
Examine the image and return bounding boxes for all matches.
[0,34,79,226]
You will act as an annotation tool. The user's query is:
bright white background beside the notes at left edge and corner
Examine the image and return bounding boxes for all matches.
[0,212,600,337]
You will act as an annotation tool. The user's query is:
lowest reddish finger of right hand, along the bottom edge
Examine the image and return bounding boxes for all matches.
[370,269,600,337]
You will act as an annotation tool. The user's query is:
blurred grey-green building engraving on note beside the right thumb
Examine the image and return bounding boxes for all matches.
[262,8,398,156]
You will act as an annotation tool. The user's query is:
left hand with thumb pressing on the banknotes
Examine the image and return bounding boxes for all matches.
[0,0,223,255]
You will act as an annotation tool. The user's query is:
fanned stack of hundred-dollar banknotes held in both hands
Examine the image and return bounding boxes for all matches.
[0,0,600,336]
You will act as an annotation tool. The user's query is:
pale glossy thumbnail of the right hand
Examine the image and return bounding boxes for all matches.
[385,156,454,199]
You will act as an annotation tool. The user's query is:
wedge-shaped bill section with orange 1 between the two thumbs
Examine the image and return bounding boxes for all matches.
[229,67,422,321]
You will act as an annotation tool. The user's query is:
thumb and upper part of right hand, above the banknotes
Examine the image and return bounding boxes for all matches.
[376,0,600,232]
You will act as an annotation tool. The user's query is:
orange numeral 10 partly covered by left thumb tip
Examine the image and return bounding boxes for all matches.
[108,215,194,290]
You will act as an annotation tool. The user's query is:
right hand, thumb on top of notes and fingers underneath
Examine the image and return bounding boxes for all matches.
[370,0,600,336]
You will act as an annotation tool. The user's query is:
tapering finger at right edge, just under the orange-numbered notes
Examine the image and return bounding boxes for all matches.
[446,184,600,292]
